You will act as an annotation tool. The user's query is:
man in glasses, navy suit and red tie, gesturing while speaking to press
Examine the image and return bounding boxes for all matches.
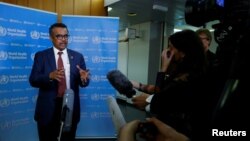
[29,23,89,141]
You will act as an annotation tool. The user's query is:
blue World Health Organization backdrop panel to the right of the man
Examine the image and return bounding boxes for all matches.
[62,15,119,138]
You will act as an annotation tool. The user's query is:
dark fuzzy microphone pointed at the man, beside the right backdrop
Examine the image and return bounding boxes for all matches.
[107,70,136,98]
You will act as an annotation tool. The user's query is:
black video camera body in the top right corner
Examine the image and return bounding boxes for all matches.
[185,0,250,27]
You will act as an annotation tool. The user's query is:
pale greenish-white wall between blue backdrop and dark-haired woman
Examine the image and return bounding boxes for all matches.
[118,22,162,88]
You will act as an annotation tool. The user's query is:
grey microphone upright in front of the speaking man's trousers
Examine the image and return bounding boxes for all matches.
[61,89,74,131]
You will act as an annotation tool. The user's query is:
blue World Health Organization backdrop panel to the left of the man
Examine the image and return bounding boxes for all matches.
[0,3,57,141]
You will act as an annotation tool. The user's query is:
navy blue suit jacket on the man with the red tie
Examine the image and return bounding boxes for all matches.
[29,48,89,125]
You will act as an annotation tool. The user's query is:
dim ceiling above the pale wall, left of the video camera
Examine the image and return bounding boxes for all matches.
[106,0,186,30]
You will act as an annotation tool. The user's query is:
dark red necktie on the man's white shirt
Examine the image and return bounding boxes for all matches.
[57,52,66,97]
